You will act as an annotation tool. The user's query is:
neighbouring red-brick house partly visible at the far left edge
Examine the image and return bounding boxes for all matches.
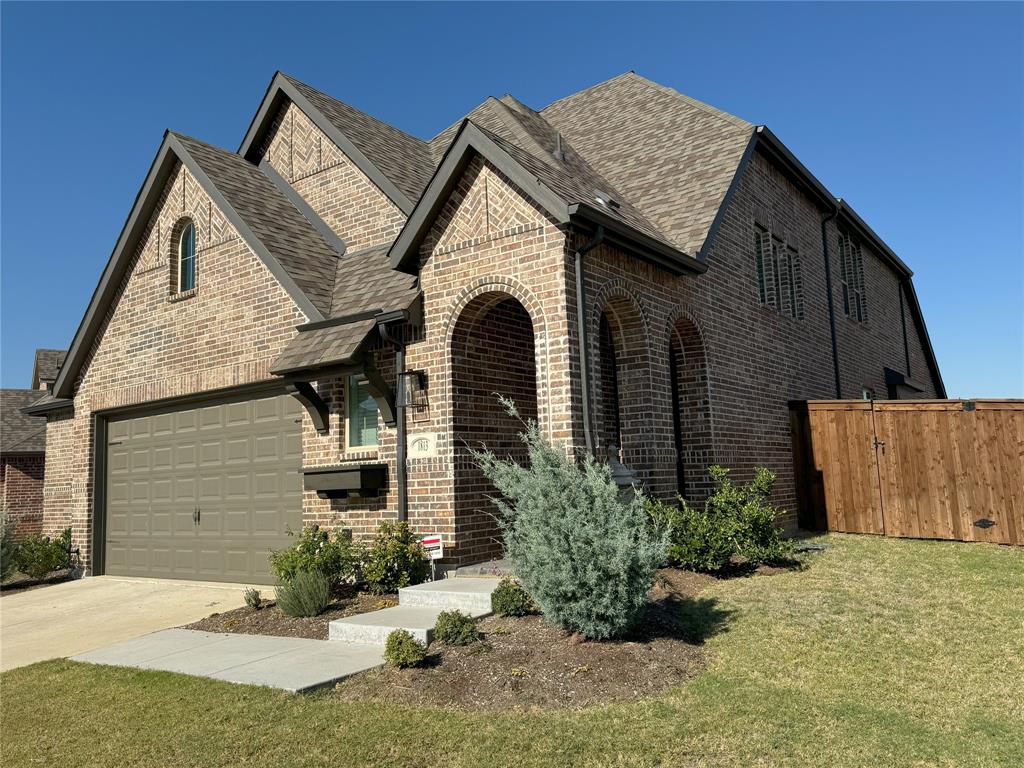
[0,349,65,538]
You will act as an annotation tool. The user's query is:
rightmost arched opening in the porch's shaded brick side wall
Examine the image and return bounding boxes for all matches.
[669,317,714,502]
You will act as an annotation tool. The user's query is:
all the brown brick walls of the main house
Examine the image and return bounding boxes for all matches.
[43,88,934,565]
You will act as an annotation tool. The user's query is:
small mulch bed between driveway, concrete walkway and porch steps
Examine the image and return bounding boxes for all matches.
[183,590,398,640]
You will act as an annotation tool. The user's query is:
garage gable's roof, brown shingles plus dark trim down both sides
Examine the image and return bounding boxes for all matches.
[53,131,337,399]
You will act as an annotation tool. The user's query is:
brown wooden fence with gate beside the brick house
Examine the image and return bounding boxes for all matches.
[791,400,1024,545]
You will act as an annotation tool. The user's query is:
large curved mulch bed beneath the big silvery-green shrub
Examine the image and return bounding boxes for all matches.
[333,568,729,710]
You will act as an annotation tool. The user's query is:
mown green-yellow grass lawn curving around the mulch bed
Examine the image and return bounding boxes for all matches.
[0,537,1024,768]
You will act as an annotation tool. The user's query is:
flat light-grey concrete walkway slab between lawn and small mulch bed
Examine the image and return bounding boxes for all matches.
[72,629,384,693]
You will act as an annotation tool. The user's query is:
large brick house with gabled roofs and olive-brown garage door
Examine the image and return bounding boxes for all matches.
[31,73,944,582]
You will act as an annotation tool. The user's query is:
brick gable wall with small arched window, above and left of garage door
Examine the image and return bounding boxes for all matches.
[43,165,306,567]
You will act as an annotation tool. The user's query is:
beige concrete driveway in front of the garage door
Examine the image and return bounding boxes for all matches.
[0,577,245,671]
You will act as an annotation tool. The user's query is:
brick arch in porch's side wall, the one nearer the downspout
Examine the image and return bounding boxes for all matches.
[590,280,655,473]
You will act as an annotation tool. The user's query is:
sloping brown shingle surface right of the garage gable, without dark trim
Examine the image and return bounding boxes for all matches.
[174,134,338,316]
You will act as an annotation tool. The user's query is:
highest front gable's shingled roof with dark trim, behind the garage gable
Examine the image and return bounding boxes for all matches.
[239,72,434,215]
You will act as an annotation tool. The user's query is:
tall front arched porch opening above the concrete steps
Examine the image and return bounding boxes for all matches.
[452,292,538,563]
